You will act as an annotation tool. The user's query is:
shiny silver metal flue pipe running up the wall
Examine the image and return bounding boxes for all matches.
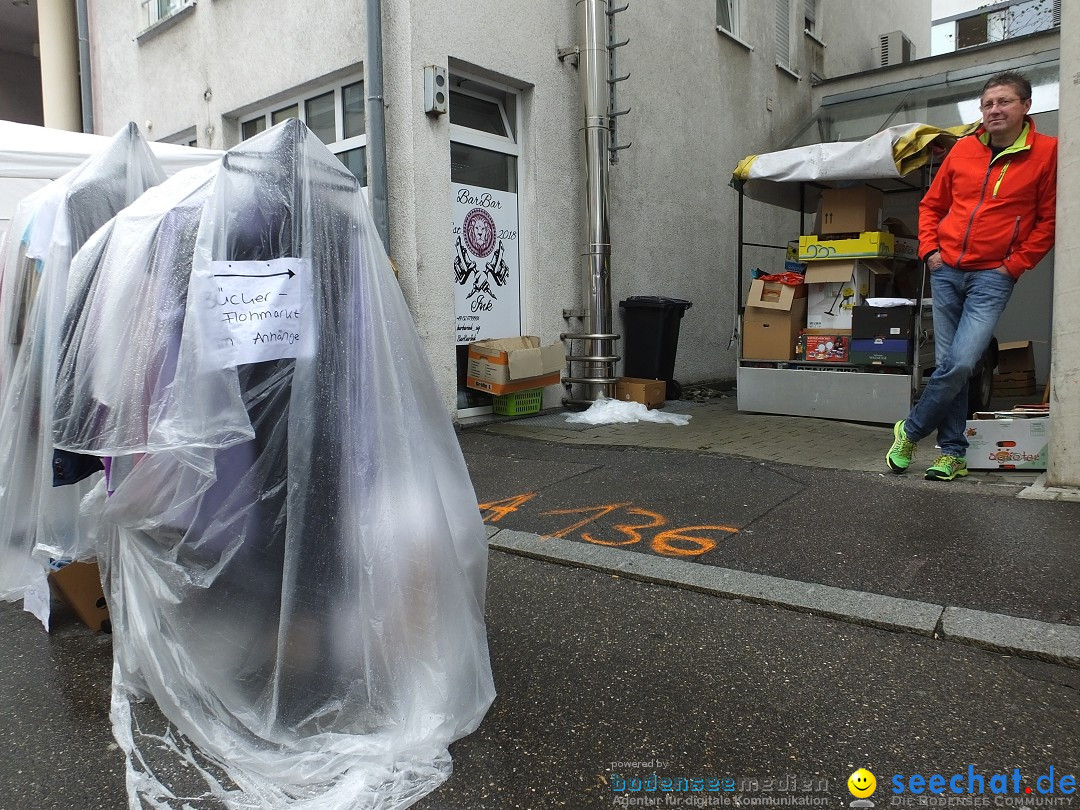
[577,0,615,401]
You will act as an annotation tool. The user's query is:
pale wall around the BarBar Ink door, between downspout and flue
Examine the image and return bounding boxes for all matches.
[383,0,580,406]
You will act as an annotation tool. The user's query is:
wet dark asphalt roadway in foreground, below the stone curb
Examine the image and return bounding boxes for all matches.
[0,552,1080,810]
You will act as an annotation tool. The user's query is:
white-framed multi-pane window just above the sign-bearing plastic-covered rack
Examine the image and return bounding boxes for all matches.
[240,81,367,186]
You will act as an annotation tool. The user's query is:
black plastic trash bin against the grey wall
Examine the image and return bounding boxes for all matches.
[619,295,693,400]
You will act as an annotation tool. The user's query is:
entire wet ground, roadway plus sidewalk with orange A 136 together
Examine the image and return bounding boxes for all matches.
[0,408,1080,810]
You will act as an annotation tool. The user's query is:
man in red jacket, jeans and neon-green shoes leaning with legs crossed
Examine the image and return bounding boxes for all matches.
[886,71,1057,481]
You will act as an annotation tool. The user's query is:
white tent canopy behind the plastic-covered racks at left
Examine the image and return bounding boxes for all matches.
[0,121,221,235]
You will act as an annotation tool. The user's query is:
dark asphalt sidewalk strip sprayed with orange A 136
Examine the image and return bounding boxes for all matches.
[461,431,1080,624]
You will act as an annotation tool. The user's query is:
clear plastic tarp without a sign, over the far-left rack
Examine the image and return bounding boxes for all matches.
[0,124,165,624]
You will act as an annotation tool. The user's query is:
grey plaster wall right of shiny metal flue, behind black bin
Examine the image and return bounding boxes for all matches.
[611,0,820,382]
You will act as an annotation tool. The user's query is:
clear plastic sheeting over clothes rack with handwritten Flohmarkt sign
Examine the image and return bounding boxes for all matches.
[55,121,495,810]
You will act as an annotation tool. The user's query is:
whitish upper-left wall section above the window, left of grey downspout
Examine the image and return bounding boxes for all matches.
[90,0,364,148]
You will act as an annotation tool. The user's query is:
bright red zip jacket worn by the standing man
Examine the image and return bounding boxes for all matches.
[919,117,1057,279]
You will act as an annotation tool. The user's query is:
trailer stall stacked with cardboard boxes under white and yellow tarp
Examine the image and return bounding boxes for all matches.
[732,124,970,422]
